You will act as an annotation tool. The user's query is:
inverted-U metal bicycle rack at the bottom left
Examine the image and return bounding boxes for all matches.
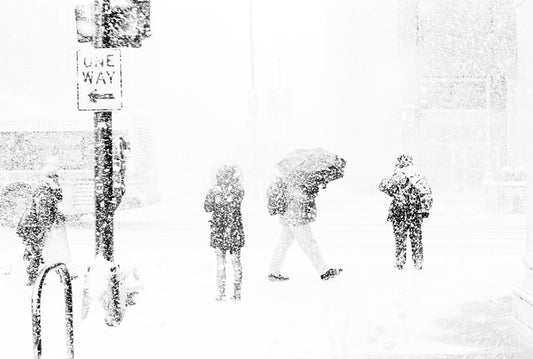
[31,263,74,359]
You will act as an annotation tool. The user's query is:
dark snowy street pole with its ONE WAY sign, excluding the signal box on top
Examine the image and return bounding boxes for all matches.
[77,0,122,326]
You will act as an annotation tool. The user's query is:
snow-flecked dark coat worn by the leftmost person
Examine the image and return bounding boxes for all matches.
[16,178,63,253]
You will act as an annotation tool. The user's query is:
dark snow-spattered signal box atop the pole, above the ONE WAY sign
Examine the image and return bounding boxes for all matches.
[75,0,151,48]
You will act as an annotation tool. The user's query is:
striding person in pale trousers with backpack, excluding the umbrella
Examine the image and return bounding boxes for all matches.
[267,173,342,281]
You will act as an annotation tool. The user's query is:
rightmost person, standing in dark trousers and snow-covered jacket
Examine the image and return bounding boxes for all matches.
[379,154,433,270]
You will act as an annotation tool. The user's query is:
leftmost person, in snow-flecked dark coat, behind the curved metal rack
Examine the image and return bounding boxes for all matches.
[16,168,63,285]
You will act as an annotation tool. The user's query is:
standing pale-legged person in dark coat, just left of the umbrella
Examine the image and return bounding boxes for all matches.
[204,165,244,300]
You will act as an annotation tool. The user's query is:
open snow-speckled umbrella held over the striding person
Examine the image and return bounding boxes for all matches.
[276,148,346,184]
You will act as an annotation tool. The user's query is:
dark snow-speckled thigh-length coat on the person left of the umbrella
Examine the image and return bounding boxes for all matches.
[204,181,244,251]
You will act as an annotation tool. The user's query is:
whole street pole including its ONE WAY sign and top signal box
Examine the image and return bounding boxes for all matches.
[75,0,151,326]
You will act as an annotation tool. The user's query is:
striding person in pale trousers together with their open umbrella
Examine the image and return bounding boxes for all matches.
[267,148,346,281]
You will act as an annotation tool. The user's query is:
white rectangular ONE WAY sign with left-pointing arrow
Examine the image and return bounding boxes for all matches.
[77,49,122,111]
